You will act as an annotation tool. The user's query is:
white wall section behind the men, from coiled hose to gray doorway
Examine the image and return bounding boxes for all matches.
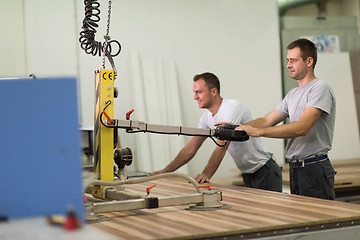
[77,0,283,176]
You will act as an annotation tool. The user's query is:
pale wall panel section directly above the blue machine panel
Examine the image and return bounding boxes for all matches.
[24,0,77,76]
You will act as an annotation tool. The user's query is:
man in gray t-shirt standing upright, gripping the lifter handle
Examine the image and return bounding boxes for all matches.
[236,39,336,199]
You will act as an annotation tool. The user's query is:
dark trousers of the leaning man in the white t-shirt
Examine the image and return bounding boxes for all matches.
[242,158,282,192]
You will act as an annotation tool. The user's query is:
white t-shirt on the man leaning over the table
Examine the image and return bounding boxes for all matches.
[199,99,273,173]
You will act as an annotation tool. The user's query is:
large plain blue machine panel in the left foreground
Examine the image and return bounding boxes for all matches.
[0,78,84,220]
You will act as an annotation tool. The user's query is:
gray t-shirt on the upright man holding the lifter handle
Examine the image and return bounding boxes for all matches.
[276,79,336,160]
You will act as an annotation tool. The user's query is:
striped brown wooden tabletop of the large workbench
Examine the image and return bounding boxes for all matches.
[90,178,360,240]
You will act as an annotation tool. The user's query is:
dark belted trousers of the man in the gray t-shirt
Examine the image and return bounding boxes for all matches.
[289,160,336,200]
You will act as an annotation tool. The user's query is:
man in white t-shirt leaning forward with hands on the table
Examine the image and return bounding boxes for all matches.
[151,73,282,192]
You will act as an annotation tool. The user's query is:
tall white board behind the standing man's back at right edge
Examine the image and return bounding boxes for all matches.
[315,52,360,160]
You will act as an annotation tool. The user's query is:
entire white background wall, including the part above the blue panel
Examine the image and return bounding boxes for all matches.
[0,0,283,176]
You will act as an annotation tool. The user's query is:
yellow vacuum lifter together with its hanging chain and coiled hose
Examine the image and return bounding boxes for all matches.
[79,0,249,216]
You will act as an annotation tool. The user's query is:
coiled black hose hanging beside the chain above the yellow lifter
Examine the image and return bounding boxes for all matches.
[79,0,121,57]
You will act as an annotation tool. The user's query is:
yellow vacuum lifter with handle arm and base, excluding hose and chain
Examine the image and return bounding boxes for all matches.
[86,69,249,214]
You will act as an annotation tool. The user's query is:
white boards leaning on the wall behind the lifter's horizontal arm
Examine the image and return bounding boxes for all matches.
[131,54,187,173]
